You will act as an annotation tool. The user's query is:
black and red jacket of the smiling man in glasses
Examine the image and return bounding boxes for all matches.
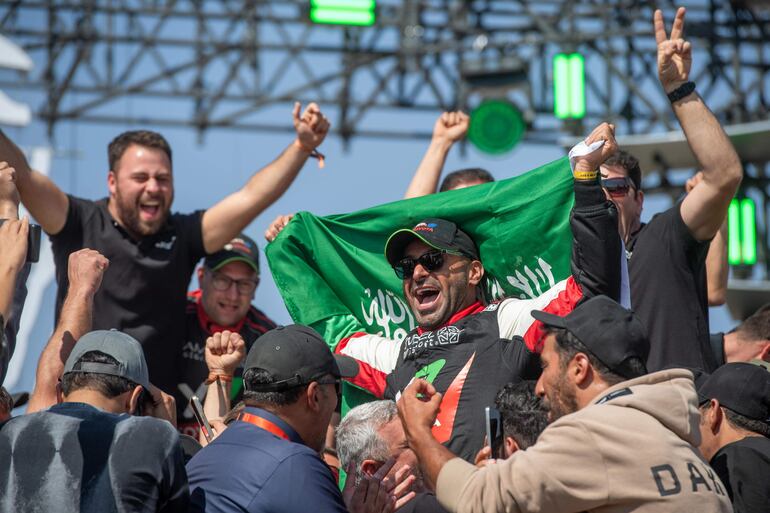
[174,291,276,439]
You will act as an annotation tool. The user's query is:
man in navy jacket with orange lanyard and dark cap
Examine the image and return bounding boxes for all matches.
[187,325,358,512]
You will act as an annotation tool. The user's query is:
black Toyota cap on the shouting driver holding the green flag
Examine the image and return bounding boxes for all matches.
[385,217,479,266]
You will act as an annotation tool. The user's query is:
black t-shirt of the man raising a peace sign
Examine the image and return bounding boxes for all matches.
[627,202,716,372]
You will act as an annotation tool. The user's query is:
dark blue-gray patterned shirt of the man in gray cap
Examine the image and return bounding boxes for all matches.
[0,403,190,513]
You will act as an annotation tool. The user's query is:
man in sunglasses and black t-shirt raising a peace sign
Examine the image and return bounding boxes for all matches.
[601,8,743,372]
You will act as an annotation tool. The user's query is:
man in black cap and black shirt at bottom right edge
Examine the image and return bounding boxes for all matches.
[698,363,770,513]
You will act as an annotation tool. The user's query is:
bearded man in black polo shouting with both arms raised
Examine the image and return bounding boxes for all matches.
[0,103,329,391]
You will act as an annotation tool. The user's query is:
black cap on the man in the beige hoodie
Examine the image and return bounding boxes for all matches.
[532,296,650,379]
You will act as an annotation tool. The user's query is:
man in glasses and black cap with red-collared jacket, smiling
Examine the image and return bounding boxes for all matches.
[174,233,276,438]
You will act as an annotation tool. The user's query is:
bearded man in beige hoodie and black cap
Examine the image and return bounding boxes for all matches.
[398,296,732,513]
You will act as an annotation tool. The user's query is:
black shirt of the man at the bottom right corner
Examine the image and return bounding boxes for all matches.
[710,436,770,513]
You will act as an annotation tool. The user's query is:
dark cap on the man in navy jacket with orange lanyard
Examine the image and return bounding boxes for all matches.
[243,324,358,392]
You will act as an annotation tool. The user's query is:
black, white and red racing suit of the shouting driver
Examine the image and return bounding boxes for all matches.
[336,179,622,461]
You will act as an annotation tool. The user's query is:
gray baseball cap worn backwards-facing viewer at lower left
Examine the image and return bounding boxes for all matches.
[64,330,150,389]
